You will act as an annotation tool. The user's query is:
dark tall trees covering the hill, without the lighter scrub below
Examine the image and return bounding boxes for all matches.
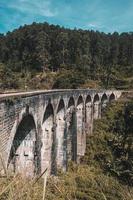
[0,22,133,90]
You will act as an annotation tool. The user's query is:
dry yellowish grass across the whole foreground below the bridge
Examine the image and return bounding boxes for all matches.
[0,164,133,200]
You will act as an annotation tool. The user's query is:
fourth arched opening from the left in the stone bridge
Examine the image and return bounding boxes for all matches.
[66,97,77,161]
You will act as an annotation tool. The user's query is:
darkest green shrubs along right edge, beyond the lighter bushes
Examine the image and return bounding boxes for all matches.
[110,102,133,185]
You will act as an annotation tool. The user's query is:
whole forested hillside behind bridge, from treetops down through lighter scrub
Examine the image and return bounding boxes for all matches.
[0,22,133,89]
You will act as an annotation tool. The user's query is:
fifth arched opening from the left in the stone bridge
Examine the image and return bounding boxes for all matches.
[77,96,85,162]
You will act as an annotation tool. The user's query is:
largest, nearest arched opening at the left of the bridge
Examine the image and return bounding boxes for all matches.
[9,114,39,176]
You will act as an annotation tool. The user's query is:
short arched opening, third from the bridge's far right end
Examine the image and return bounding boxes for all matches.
[93,94,100,119]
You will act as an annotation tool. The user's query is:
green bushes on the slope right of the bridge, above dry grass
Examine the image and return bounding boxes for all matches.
[84,102,133,185]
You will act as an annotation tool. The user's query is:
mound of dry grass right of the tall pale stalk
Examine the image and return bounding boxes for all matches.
[47,165,133,200]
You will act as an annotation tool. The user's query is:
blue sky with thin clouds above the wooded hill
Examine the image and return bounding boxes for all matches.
[0,0,133,33]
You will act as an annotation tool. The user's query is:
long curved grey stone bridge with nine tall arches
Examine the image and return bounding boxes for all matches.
[0,89,121,176]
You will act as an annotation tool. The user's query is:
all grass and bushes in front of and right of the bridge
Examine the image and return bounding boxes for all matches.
[0,99,133,200]
